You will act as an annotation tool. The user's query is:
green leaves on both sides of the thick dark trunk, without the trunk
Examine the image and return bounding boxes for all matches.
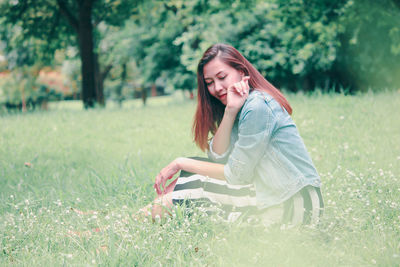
[0,0,138,66]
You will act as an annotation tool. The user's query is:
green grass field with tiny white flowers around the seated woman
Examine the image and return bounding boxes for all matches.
[0,92,400,266]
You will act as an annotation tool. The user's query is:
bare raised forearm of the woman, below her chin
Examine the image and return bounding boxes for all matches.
[212,108,238,155]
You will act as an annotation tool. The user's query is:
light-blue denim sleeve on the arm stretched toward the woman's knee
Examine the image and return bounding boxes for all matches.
[224,96,276,185]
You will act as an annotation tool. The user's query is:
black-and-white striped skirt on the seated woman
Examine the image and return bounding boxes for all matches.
[172,172,324,225]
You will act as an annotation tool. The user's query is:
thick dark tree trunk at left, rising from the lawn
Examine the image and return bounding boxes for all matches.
[78,0,96,108]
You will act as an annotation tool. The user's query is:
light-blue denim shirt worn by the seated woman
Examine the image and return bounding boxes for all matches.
[208,90,321,209]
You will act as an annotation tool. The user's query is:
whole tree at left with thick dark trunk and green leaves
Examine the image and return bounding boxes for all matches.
[0,0,139,108]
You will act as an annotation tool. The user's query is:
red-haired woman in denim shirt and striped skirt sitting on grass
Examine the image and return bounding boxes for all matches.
[141,44,323,224]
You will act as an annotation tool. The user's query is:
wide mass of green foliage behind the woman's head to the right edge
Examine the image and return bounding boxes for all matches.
[129,0,400,91]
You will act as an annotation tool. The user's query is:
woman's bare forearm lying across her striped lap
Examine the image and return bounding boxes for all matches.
[175,158,226,180]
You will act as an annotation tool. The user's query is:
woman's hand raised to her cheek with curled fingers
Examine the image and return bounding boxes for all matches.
[226,76,250,112]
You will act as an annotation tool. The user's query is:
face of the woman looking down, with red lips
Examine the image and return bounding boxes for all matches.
[203,58,244,106]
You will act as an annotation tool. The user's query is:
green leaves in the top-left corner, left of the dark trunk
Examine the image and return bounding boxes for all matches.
[0,0,75,66]
